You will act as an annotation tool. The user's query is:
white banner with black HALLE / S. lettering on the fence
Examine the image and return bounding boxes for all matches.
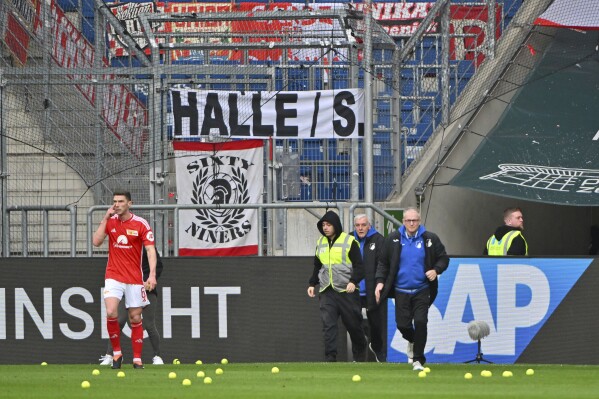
[169,89,364,139]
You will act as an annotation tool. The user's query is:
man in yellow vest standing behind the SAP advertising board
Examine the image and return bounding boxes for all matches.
[484,208,528,256]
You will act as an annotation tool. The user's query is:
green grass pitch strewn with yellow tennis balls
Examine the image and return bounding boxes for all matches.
[0,362,599,399]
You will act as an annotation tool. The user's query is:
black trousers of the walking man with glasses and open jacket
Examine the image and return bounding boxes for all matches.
[395,288,430,364]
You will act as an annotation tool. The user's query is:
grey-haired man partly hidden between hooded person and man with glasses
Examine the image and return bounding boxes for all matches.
[350,213,387,362]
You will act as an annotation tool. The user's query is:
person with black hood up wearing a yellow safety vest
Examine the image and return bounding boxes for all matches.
[308,211,368,362]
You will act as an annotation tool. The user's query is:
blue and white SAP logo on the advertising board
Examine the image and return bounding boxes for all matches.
[389,258,591,362]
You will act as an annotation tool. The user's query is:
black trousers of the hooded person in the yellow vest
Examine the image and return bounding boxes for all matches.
[318,288,368,361]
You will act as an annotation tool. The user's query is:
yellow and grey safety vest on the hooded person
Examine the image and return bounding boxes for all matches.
[316,233,355,292]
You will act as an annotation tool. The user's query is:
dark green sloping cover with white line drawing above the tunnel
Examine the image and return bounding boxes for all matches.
[450,29,599,206]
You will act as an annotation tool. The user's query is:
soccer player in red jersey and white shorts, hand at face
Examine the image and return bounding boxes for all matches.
[93,191,156,369]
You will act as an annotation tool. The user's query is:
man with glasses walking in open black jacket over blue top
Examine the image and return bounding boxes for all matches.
[375,208,449,371]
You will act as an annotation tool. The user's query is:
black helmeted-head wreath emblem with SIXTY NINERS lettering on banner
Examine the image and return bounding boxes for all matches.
[185,156,252,244]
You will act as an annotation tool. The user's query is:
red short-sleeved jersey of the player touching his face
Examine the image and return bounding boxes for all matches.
[105,214,154,284]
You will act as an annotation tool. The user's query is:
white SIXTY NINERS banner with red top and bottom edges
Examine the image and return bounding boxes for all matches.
[173,140,264,256]
